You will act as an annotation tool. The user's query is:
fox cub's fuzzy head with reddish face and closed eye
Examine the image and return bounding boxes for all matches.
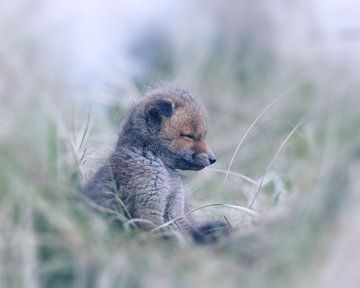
[119,88,216,170]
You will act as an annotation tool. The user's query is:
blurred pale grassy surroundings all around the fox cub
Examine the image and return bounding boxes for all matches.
[0,0,360,287]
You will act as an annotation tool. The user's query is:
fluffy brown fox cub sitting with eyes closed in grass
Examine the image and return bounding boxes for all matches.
[84,87,230,243]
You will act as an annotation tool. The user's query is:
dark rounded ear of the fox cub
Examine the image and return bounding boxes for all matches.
[146,100,174,130]
